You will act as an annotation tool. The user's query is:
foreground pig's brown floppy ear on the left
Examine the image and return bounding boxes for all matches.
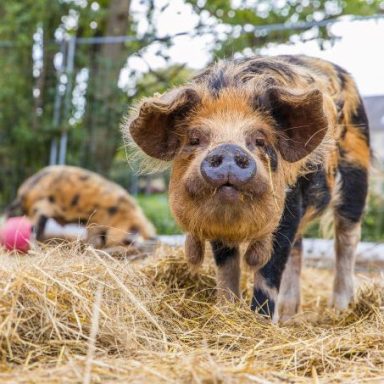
[129,87,200,161]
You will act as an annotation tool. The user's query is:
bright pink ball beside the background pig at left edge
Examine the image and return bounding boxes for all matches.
[0,216,32,252]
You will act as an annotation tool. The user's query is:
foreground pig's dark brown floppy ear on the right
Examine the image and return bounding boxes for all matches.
[260,87,328,163]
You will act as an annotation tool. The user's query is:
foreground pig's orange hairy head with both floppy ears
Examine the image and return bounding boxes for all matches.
[129,84,327,243]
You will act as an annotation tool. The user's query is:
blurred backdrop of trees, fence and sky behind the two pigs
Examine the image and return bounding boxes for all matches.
[0,0,384,241]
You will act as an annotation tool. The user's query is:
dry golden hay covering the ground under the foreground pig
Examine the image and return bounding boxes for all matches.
[0,246,384,383]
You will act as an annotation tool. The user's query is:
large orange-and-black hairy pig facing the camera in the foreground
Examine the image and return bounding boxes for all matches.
[123,56,370,320]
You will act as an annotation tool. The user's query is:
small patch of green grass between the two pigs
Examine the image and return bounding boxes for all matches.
[136,193,182,235]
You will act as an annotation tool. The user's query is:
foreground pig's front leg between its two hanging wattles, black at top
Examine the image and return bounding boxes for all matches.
[211,241,240,301]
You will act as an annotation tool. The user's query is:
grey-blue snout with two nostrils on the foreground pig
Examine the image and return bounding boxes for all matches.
[200,144,256,187]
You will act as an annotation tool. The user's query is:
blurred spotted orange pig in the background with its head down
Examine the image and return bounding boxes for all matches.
[8,165,156,248]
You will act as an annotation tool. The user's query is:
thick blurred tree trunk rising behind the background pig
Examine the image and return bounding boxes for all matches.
[85,0,130,174]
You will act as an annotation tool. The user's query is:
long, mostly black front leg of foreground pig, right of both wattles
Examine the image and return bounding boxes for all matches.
[251,186,302,321]
